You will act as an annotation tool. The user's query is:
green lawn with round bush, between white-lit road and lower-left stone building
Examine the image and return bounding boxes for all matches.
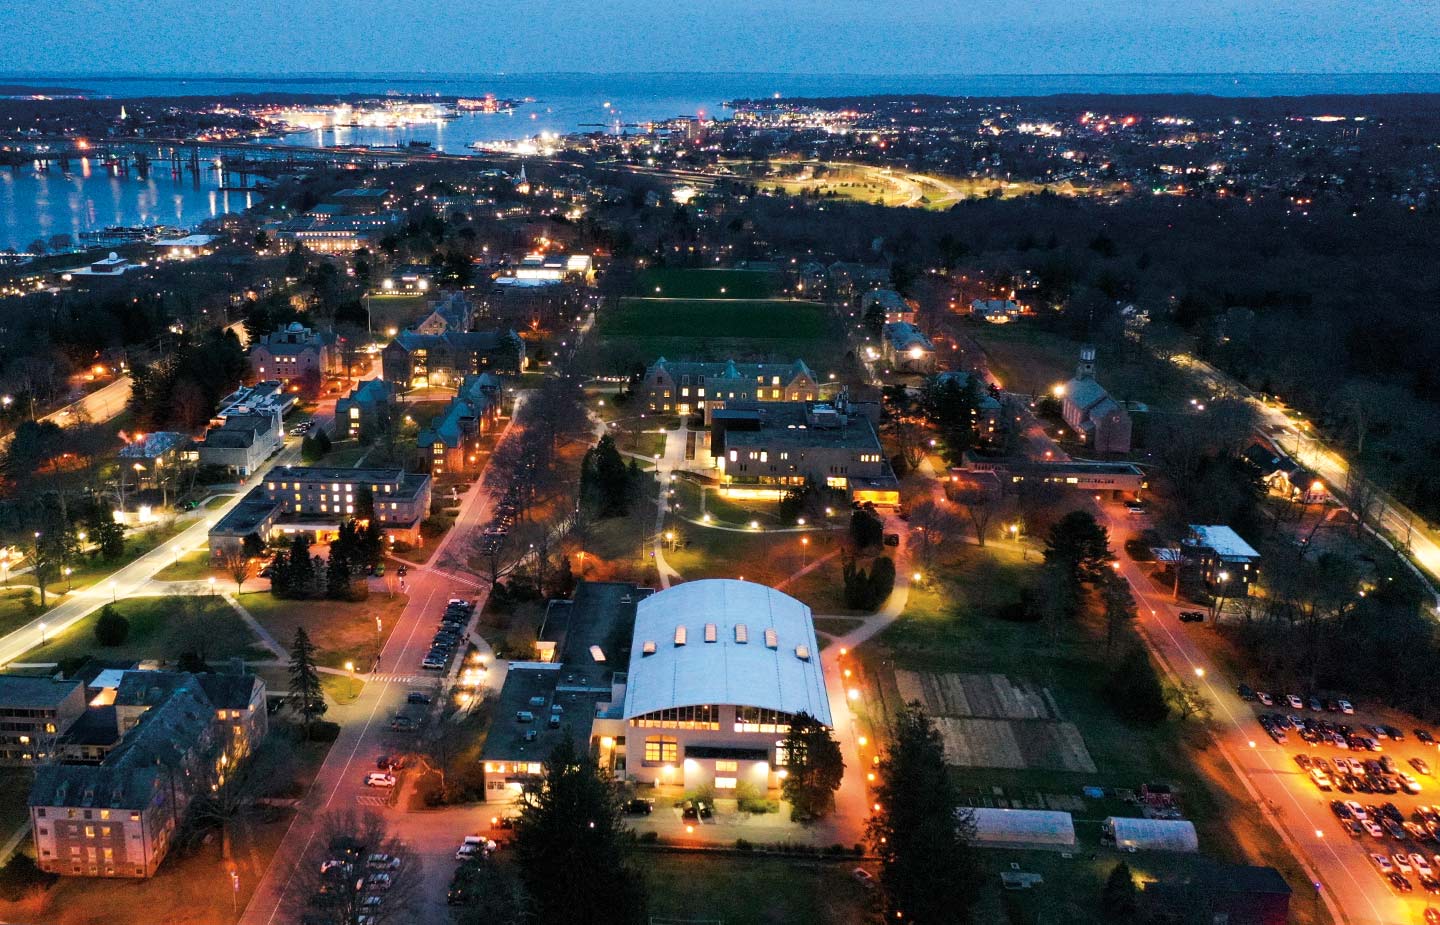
[23,595,269,663]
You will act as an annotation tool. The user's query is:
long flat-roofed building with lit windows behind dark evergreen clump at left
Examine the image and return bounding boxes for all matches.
[210,465,431,559]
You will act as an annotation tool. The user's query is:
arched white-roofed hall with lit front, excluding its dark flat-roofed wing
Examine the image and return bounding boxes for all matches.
[616,579,831,798]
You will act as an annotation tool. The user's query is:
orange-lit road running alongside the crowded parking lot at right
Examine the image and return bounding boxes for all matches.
[1102,504,1437,925]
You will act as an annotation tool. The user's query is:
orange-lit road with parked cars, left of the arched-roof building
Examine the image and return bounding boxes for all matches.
[240,409,524,925]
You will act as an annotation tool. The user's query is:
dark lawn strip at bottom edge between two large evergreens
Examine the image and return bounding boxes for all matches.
[636,852,878,925]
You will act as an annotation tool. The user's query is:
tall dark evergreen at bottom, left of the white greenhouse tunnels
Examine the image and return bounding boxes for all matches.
[867,702,979,925]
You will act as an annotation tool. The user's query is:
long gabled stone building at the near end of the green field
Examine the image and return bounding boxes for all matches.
[641,357,821,426]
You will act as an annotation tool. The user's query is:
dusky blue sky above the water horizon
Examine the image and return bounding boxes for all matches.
[0,0,1440,75]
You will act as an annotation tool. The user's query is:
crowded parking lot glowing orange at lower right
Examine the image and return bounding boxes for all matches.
[1238,684,1440,899]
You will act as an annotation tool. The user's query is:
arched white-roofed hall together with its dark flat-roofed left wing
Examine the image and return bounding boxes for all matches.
[481,579,832,801]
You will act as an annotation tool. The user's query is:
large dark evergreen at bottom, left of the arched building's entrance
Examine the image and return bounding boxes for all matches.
[514,736,645,925]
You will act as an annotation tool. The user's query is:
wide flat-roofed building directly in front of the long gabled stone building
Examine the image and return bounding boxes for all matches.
[710,395,900,504]
